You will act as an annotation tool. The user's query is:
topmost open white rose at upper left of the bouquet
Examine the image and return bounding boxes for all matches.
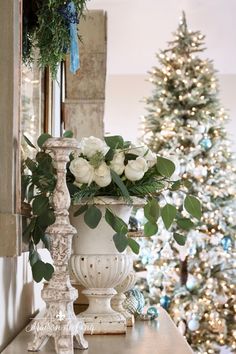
[80,136,110,158]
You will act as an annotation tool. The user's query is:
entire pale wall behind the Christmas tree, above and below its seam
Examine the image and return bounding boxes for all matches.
[88,0,236,151]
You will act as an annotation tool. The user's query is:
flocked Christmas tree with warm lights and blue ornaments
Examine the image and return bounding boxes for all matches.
[137,14,236,354]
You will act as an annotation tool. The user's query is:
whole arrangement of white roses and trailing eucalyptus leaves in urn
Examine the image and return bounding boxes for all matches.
[22,131,201,282]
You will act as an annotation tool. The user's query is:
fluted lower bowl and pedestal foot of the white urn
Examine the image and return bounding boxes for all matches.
[71,254,132,334]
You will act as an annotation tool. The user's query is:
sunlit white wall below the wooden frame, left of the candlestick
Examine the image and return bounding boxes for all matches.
[0,250,50,352]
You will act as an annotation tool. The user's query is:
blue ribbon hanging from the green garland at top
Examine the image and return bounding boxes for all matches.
[59,1,80,74]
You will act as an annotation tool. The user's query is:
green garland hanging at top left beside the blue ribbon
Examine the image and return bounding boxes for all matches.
[23,0,87,79]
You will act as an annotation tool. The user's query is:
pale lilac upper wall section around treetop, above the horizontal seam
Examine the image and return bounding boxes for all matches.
[88,0,236,75]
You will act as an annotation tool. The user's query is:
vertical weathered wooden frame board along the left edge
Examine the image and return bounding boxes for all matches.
[0,0,21,256]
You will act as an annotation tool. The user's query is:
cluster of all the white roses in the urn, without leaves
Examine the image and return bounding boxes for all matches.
[69,136,157,187]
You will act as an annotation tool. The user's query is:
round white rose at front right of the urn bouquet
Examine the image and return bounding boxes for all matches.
[125,157,148,181]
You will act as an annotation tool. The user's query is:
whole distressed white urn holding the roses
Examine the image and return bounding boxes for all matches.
[70,197,142,334]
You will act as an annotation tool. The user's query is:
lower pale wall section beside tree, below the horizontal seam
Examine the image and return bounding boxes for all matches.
[104,75,236,151]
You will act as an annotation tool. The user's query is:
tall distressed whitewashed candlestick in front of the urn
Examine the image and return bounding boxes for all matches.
[28,138,88,354]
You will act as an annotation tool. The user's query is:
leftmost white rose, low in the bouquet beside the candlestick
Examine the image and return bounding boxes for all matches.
[70,157,94,185]
